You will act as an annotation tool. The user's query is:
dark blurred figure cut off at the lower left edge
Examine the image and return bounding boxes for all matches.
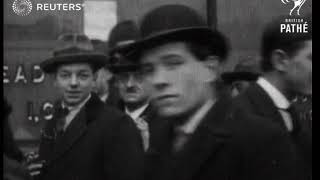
[2,98,30,180]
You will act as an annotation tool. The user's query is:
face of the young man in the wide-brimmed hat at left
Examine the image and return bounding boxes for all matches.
[54,63,94,106]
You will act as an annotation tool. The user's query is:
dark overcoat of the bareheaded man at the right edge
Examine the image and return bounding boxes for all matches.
[213,83,312,180]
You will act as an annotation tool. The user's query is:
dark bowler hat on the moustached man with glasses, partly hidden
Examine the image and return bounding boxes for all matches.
[107,20,140,73]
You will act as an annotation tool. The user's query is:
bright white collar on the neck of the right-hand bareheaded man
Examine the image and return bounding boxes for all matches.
[257,77,290,109]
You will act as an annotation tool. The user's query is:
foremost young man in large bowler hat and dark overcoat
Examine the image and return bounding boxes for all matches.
[116,5,228,180]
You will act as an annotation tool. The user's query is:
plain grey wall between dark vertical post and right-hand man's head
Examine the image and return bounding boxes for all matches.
[217,0,312,67]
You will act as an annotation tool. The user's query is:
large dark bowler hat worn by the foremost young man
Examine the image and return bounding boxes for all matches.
[119,4,228,60]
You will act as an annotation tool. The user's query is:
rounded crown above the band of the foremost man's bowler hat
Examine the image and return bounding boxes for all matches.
[140,4,208,37]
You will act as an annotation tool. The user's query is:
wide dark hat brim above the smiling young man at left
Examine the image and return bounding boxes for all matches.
[40,53,108,73]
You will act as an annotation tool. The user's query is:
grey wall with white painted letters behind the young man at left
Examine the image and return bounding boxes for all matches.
[3,0,83,152]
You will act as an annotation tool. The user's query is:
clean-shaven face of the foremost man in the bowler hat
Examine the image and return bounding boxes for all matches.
[141,42,215,117]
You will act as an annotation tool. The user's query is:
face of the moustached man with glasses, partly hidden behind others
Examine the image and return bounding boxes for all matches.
[116,71,150,104]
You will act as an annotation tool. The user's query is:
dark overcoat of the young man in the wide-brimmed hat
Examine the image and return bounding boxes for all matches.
[40,94,144,180]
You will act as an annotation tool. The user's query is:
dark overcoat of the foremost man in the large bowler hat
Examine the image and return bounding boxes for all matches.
[145,99,231,180]
